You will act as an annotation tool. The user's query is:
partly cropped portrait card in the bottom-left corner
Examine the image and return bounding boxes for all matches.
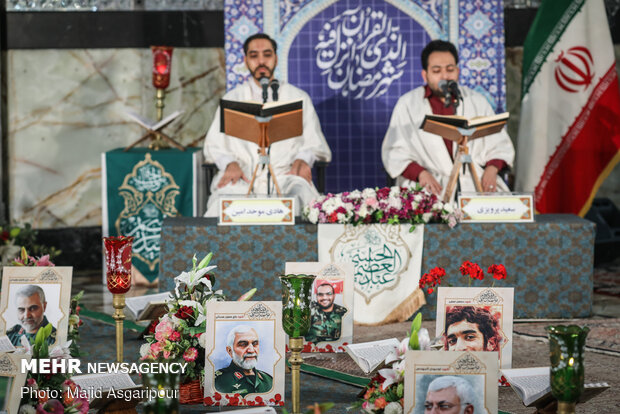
[0,352,30,414]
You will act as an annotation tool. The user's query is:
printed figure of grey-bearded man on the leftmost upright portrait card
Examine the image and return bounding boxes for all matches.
[6,285,56,346]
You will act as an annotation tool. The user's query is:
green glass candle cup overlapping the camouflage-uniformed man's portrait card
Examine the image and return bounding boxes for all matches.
[280,275,316,338]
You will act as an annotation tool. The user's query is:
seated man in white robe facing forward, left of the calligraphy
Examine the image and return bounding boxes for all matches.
[204,33,331,217]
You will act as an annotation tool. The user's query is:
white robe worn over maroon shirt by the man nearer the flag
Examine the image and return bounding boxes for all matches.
[381,86,515,197]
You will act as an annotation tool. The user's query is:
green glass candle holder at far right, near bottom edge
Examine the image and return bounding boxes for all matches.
[545,325,590,414]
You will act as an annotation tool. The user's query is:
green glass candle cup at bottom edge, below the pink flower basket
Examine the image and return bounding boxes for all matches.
[142,359,181,414]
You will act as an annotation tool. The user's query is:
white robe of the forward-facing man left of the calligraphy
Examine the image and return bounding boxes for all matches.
[204,80,331,217]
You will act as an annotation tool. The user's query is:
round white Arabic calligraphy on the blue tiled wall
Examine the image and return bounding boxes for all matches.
[315,6,407,99]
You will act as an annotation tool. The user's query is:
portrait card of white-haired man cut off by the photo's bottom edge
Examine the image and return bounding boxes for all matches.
[404,351,499,414]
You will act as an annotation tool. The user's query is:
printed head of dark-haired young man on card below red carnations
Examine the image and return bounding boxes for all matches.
[444,306,503,351]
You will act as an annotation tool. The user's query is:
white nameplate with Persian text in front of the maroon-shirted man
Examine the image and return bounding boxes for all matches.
[459,194,534,223]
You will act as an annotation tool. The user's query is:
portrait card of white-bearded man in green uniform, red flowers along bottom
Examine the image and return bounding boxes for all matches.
[204,302,285,406]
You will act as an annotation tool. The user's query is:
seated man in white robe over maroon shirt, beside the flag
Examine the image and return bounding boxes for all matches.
[381,40,514,197]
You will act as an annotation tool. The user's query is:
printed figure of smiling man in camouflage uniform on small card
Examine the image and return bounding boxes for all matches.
[305,280,347,343]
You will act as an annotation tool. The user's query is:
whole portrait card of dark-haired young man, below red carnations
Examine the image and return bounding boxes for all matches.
[435,287,514,369]
